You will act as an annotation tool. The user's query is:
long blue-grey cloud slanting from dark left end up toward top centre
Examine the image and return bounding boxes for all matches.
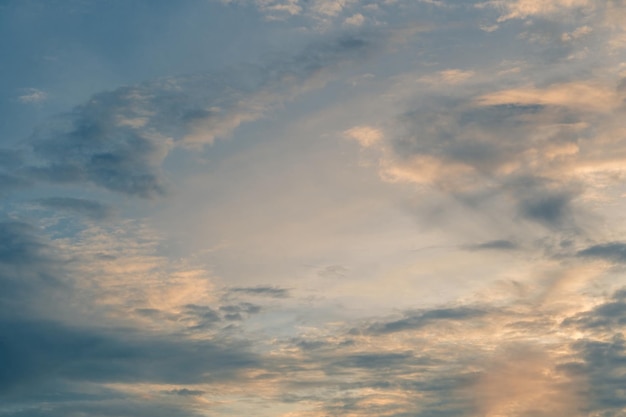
[25,37,372,198]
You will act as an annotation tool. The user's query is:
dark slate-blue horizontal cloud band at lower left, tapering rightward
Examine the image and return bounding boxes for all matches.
[0,320,258,392]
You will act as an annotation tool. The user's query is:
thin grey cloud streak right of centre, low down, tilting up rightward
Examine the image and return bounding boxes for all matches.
[357,307,488,334]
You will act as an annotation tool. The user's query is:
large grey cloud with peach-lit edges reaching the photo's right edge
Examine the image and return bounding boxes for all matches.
[360,72,623,234]
